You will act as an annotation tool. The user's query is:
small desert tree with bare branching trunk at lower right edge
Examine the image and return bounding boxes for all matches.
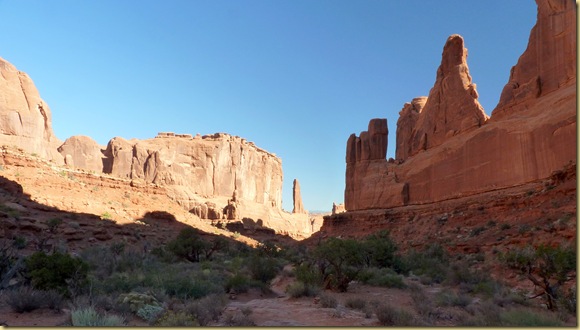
[501,244,576,310]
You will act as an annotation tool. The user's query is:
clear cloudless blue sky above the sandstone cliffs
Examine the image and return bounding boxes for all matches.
[0,0,537,211]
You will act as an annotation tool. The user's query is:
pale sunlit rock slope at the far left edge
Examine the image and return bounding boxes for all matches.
[0,58,63,164]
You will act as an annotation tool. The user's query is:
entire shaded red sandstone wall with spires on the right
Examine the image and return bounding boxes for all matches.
[345,0,577,211]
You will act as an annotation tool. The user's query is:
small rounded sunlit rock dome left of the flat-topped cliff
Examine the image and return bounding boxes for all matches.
[58,135,105,173]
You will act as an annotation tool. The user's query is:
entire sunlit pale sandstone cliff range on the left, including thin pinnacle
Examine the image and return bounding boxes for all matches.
[0,58,321,237]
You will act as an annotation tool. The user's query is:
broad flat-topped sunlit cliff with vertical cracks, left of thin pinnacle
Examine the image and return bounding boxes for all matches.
[104,133,282,208]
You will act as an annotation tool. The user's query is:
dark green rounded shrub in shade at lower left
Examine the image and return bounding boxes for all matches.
[25,252,89,295]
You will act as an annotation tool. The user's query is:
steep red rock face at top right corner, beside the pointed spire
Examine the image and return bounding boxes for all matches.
[492,0,576,120]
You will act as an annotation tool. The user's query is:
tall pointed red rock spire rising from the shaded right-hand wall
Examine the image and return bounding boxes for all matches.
[408,35,488,159]
